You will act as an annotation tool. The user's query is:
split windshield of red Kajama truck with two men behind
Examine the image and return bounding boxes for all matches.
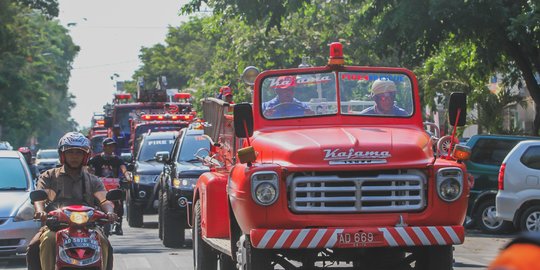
[261,72,414,119]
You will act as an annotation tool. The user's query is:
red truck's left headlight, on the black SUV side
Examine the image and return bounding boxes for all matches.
[251,171,279,206]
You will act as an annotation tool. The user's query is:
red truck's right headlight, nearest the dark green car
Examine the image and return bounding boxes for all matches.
[437,168,463,202]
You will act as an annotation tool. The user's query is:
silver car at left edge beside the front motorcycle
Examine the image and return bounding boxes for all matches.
[0,151,41,257]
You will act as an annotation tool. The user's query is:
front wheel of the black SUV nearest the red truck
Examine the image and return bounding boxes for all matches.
[161,192,186,248]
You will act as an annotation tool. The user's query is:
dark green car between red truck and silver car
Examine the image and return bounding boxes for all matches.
[465,135,539,234]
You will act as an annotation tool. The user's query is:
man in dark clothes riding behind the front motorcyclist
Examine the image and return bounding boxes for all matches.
[88,138,131,235]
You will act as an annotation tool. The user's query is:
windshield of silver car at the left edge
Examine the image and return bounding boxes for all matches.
[0,158,28,190]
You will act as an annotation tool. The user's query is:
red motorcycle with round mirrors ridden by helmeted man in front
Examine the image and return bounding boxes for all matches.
[30,190,122,269]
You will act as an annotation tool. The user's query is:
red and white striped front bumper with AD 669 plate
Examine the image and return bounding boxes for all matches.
[250,226,465,249]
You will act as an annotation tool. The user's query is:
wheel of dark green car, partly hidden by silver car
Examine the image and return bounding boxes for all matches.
[475,199,512,234]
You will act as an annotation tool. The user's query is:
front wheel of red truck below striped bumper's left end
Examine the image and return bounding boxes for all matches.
[236,235,274,270]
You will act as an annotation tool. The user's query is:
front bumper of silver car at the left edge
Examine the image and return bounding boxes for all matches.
[0,218,41,257]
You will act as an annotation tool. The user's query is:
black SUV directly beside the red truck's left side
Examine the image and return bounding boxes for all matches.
[158,128,210,247]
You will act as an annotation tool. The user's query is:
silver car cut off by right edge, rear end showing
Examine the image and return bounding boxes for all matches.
[496,140,540,231]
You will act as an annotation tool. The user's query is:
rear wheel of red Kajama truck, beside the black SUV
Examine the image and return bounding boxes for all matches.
[192,201,217,270]
